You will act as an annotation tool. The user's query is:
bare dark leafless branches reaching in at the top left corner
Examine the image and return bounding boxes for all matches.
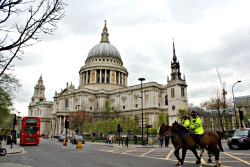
[0,0,65,75]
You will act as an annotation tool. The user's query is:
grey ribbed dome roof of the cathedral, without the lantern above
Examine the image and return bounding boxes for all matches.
[87,43,121,60]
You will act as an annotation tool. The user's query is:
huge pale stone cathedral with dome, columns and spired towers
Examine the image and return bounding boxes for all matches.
[29,22,188,134]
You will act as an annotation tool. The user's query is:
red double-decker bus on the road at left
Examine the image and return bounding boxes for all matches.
[20,116,40,145]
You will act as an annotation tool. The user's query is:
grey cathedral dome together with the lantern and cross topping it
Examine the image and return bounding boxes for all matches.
[86,21,122,62]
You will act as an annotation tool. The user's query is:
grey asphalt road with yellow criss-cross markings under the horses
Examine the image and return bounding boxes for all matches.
[0,139,250,167]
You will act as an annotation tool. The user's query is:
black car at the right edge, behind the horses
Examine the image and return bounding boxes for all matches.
[227,128,250,149]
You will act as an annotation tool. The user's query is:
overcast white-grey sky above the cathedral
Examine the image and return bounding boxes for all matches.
[14,0,250,115]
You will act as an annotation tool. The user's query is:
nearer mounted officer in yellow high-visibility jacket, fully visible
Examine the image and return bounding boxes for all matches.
[190,111,204,148]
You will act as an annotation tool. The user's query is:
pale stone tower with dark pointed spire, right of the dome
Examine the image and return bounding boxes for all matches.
[167,42,188,125]
